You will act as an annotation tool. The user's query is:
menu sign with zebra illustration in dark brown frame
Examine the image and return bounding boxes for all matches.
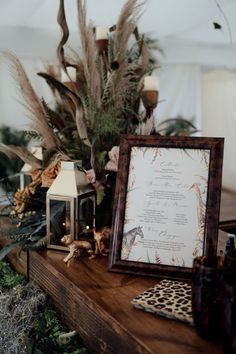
[109,135,224,279]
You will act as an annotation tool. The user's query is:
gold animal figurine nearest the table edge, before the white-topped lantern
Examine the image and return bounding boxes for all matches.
[61,235,95,264]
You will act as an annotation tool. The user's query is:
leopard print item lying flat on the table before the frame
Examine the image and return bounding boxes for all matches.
[131,279,193,325]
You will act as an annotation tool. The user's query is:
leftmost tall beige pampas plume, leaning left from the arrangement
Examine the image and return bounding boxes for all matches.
[5,52,59,149]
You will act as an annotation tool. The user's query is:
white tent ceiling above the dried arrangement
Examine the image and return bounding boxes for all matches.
[0,0,236,67]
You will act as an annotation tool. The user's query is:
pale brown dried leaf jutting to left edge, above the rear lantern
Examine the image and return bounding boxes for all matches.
[0,144,42,168]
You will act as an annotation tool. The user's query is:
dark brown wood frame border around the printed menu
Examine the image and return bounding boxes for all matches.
[108,135,224,279]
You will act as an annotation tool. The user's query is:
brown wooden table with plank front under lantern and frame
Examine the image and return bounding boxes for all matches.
[26,251,223,354]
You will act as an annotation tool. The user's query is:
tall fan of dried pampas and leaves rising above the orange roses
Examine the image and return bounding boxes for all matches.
[1,0,159,178]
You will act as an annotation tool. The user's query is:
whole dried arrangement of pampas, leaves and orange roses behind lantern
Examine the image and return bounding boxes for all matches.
[0,0,194,258]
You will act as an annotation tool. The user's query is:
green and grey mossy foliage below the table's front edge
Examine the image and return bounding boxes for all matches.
[0,261,88,354]
